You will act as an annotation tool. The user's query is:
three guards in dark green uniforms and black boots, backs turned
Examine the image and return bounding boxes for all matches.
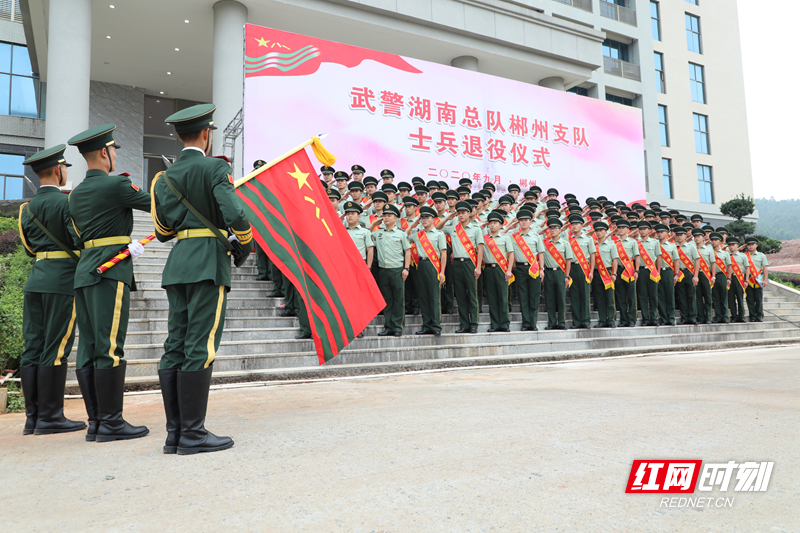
[19,104,253,455]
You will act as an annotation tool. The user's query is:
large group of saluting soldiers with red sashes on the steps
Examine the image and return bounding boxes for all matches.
[256,167,769,339]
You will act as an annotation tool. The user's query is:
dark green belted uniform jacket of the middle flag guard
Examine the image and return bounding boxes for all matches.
[69,170,150,291]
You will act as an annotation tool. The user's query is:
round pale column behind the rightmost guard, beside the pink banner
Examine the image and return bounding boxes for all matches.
[212,0,247,162]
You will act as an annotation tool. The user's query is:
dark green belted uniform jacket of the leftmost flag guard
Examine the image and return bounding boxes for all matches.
[19,185,80,296]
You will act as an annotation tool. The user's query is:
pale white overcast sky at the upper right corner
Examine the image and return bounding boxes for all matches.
[736,0,800,200]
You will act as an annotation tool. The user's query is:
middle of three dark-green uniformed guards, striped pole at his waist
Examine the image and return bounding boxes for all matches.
[69,124,150,442]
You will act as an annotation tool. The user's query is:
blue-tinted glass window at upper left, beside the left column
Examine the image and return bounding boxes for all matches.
[0,43,44,118]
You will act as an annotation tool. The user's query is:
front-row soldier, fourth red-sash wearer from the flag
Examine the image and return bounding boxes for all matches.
[510,204,544,331]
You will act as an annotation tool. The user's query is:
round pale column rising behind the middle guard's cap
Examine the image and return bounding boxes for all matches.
[44,0,92,187]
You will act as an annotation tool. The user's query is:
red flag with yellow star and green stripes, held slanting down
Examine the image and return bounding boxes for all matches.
[237,150,386,364]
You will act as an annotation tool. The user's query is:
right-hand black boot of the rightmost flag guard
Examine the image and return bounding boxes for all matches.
[178,366,233,455]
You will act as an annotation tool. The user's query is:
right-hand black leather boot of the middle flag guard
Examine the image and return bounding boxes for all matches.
[94,360,150,442]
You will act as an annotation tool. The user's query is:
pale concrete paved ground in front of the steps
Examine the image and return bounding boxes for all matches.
[0,346,800,533]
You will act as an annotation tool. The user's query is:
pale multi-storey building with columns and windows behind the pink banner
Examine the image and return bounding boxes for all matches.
[0,0,753,221]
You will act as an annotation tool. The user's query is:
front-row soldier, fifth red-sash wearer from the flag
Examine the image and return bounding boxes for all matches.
[542,217,575,329]
